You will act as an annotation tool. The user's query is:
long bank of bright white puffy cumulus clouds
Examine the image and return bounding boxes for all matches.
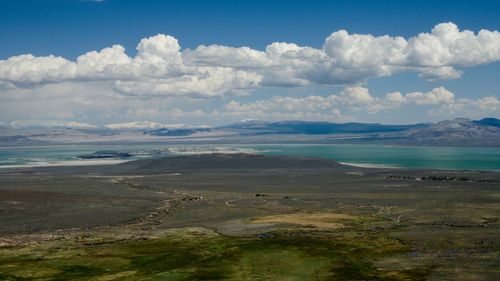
[0,23,500,97]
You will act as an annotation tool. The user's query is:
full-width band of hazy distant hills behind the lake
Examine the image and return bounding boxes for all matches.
[0,118,500,147]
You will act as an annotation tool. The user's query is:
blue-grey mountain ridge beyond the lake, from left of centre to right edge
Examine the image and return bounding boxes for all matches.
[148,118,500,146]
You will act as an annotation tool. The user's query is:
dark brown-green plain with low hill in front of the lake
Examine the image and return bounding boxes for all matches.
[0,153,500,280]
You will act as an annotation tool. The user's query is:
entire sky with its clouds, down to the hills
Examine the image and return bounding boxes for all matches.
[0,0,500,128]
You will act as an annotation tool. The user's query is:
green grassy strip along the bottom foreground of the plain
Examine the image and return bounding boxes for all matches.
[0,230,429,280]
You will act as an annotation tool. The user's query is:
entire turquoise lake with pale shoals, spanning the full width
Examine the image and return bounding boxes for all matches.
[0,144,500,171]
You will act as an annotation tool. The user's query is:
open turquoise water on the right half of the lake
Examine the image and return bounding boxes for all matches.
[261,145,500,171]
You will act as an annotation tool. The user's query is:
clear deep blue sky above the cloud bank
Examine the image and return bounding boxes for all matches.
[0,0,500,58]
